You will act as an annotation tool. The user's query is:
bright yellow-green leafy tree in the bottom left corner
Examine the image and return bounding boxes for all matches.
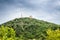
[0,26,15,40]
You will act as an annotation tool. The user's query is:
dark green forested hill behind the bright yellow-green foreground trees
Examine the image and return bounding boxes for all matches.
[0,17,60,40]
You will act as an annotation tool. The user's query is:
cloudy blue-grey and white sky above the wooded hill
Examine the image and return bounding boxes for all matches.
[0,0,60,24]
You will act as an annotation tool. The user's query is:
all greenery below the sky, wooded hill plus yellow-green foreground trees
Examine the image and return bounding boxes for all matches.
[0,17,60,40]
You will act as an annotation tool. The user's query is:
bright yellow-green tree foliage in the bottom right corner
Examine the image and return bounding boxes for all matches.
[46,29,60,40]
